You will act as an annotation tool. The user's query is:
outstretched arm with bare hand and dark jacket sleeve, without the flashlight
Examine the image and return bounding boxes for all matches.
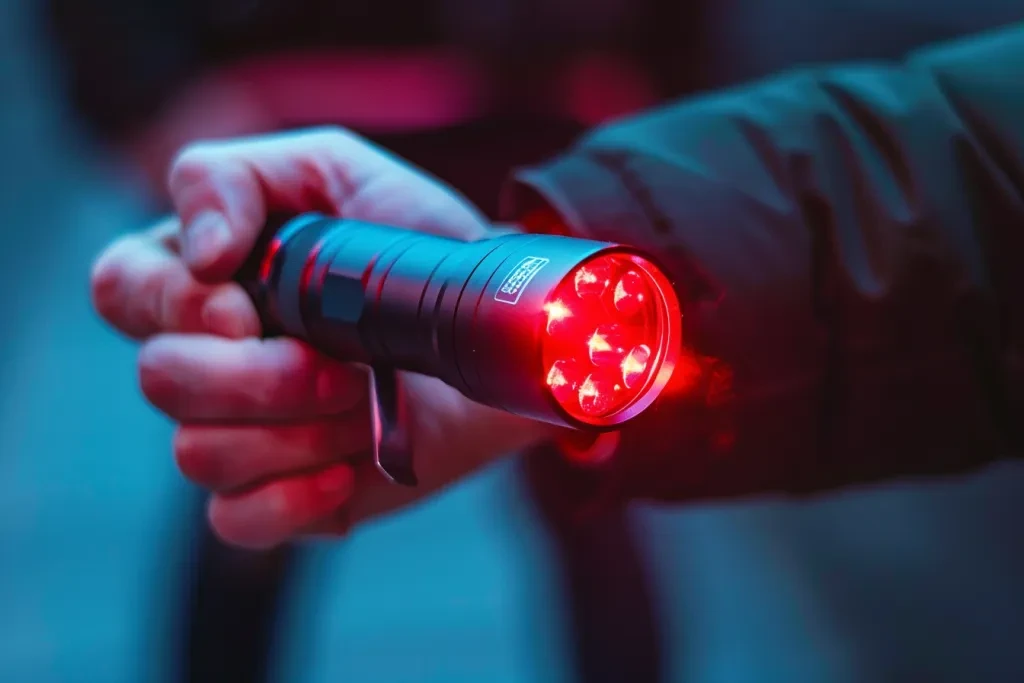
[92,32,1024,547]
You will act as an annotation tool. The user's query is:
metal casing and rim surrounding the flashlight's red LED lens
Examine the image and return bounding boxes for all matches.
[460,234,682,432]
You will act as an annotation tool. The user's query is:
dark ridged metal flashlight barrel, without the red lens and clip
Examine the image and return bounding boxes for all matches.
[243,214,671,429]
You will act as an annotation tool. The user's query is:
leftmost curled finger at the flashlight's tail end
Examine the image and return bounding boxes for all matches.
[91,221,260,339]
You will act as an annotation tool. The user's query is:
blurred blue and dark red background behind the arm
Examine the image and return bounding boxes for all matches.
[0,0,1024,683]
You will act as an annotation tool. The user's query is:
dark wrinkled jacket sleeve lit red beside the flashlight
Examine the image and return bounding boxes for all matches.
[508,22,1024,507]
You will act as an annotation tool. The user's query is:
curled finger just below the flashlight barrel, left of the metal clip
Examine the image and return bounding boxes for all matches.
[139,335,368,422]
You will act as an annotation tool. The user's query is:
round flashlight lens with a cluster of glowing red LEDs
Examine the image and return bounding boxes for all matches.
[543,252,680,425]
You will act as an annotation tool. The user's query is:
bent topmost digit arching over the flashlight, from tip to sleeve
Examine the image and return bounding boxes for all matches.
[169,128,495,282]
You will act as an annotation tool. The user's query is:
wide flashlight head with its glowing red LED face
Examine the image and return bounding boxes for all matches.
[457,242,681,430]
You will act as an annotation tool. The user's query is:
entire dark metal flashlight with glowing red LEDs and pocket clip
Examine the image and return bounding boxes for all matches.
[240,214,681,484]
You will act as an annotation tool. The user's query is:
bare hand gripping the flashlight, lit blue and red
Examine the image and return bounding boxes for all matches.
[92,129,554,548]
